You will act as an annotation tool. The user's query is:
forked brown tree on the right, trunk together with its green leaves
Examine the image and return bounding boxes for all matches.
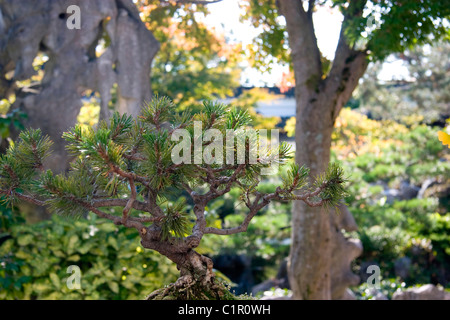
[246,0,450,299]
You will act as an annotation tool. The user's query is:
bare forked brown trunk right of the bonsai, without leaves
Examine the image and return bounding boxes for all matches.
[279,0,368,299]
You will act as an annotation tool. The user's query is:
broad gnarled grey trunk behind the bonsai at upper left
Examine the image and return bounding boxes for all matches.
[0,0,159,172]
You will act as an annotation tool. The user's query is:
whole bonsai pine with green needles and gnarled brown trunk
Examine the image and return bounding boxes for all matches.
[0,98,345,299]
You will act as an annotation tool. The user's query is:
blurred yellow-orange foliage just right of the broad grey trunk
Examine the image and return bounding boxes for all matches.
[137,0,242,112]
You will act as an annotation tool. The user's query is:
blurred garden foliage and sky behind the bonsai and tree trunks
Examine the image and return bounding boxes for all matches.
[0,0,450,300]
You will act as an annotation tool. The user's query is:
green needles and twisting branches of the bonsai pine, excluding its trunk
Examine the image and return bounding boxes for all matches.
[0,98,346,241]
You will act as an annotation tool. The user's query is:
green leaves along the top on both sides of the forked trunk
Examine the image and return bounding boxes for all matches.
[242,0,450,67]
